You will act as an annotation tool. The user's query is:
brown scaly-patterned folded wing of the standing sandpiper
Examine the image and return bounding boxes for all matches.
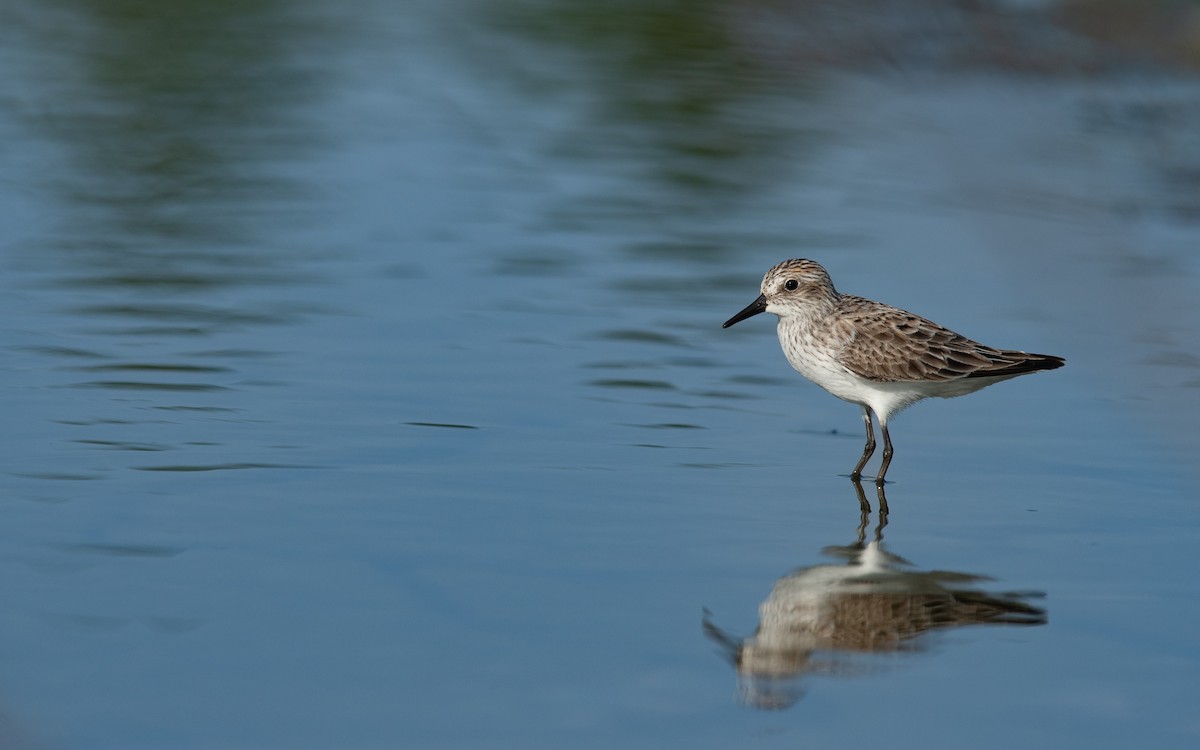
[834,294,1062,383]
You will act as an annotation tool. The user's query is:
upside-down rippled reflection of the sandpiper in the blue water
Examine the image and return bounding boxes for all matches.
[703,482,1046,708]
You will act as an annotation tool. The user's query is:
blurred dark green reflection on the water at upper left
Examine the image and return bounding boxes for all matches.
[22,0,333,288]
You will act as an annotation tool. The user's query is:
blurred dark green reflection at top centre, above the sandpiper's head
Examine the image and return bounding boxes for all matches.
[492,0,811,193]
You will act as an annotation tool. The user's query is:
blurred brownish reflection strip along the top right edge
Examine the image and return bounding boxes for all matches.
[731,0,1200,76]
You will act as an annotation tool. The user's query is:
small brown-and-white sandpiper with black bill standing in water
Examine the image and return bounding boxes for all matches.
[721,258,1066,485]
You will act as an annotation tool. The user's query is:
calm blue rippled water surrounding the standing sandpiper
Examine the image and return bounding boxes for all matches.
[0,0,1200,749]
